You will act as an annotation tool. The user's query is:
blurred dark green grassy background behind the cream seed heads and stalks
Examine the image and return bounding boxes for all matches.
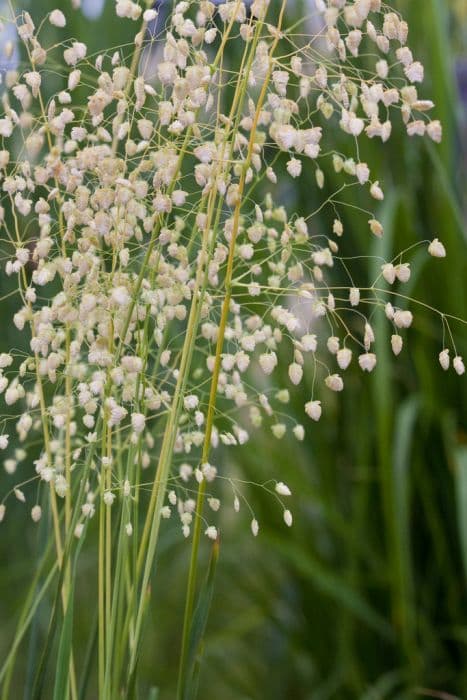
[0,0,467,700]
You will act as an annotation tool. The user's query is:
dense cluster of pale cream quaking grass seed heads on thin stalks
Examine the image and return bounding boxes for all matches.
[0,0,464,539]
